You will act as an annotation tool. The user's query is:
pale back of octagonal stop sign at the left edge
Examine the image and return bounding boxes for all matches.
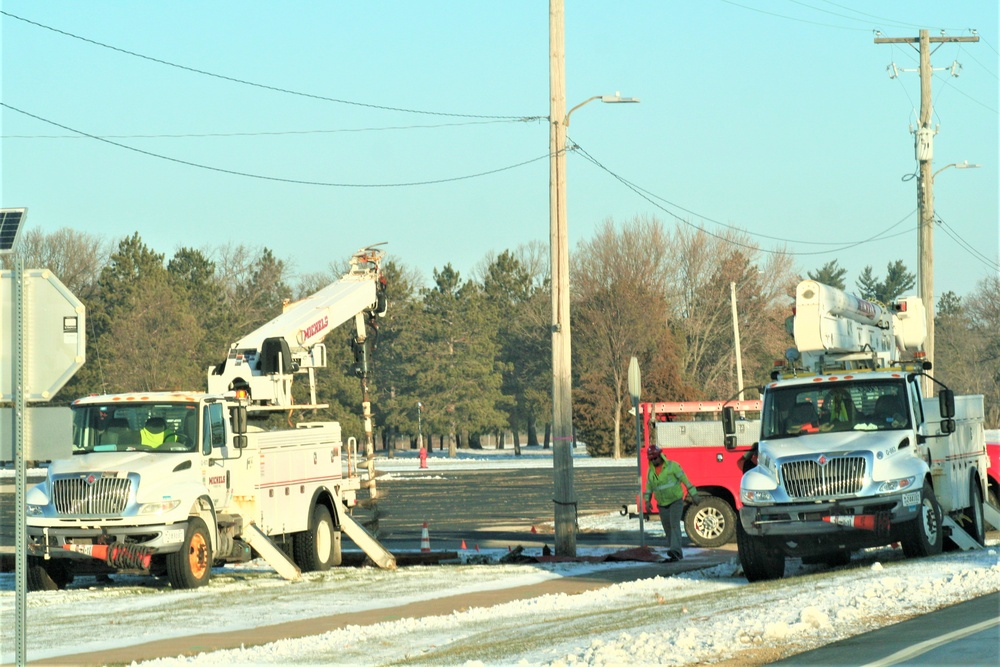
[0,269,86,401]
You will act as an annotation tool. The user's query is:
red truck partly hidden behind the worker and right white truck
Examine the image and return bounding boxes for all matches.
[622,401,761,547]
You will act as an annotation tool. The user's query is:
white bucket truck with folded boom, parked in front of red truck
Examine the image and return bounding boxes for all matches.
[723,280,988,581]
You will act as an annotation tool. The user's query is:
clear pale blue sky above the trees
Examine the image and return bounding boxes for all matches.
[0,0,1000,295]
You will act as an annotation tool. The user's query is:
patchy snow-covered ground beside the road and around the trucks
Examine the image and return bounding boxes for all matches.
[0,457,1000,667]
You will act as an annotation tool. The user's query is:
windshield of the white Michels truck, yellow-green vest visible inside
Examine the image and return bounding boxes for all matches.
[73,403,198,454]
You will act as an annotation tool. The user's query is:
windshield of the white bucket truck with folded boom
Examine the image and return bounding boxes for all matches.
[761,380,913,439]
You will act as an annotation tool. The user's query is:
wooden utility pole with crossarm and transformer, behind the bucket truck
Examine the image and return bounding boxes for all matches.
[875,30,979,397]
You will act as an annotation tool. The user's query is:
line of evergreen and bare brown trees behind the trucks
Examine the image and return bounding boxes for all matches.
[5,217,1000,457]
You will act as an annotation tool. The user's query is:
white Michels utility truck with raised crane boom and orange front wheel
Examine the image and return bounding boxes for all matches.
[27,248,395,590]
